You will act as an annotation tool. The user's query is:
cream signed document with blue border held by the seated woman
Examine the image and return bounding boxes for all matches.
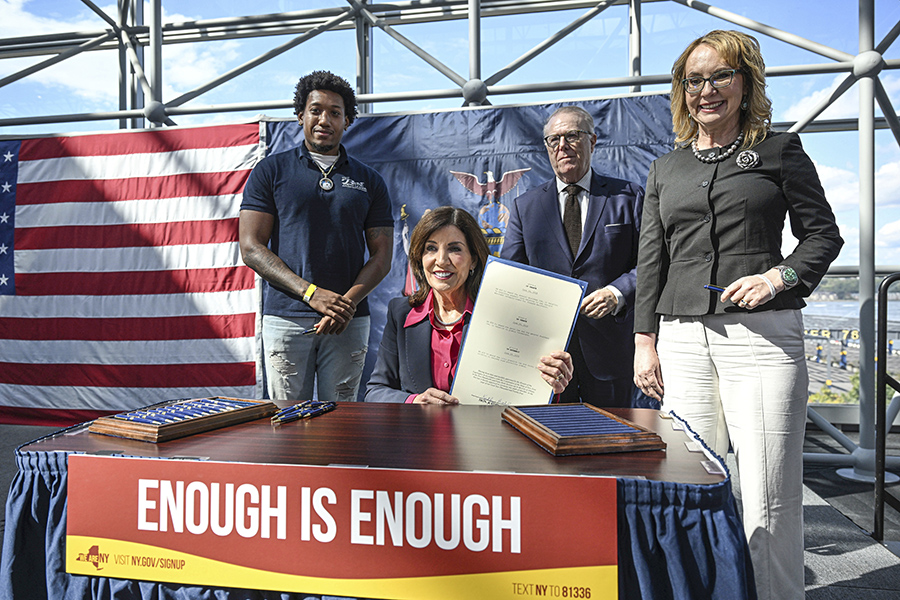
[450,256,587,405]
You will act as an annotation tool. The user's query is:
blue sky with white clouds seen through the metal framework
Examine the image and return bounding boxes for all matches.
[0,0,900,265]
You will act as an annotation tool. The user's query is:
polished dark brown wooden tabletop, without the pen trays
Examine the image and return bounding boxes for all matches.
[21,402,725,484]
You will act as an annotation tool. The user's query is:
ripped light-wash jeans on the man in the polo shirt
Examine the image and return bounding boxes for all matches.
[262,315,370,402]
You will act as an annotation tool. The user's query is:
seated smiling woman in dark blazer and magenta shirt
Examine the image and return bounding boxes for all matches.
[366,206,572,404]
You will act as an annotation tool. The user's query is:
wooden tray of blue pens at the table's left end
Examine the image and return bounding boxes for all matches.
[88,396,278,443]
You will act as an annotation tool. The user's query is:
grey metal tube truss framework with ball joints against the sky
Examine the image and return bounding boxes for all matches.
[0,0,900,488]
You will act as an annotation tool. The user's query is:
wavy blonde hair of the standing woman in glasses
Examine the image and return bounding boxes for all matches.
[671,29,772,148]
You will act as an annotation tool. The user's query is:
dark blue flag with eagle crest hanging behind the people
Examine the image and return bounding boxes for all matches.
[266,95,674,397]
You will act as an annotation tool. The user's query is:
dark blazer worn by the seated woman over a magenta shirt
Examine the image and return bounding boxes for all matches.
[366,298,469,402]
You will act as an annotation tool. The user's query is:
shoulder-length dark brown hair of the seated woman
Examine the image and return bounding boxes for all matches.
[409,206,490,306]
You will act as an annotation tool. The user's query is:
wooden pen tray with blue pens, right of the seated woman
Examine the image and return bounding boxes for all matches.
[502,404,666,456]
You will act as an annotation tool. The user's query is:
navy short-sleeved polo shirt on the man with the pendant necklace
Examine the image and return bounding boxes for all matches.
[241,144,394,317]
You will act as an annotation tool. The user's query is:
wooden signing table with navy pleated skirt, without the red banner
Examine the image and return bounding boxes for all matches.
[0,403,755,600]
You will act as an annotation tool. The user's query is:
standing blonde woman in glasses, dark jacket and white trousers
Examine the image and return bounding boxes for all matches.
[634,31,843,599]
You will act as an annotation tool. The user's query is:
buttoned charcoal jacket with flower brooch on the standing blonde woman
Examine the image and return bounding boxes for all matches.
[635,133,844,333]
